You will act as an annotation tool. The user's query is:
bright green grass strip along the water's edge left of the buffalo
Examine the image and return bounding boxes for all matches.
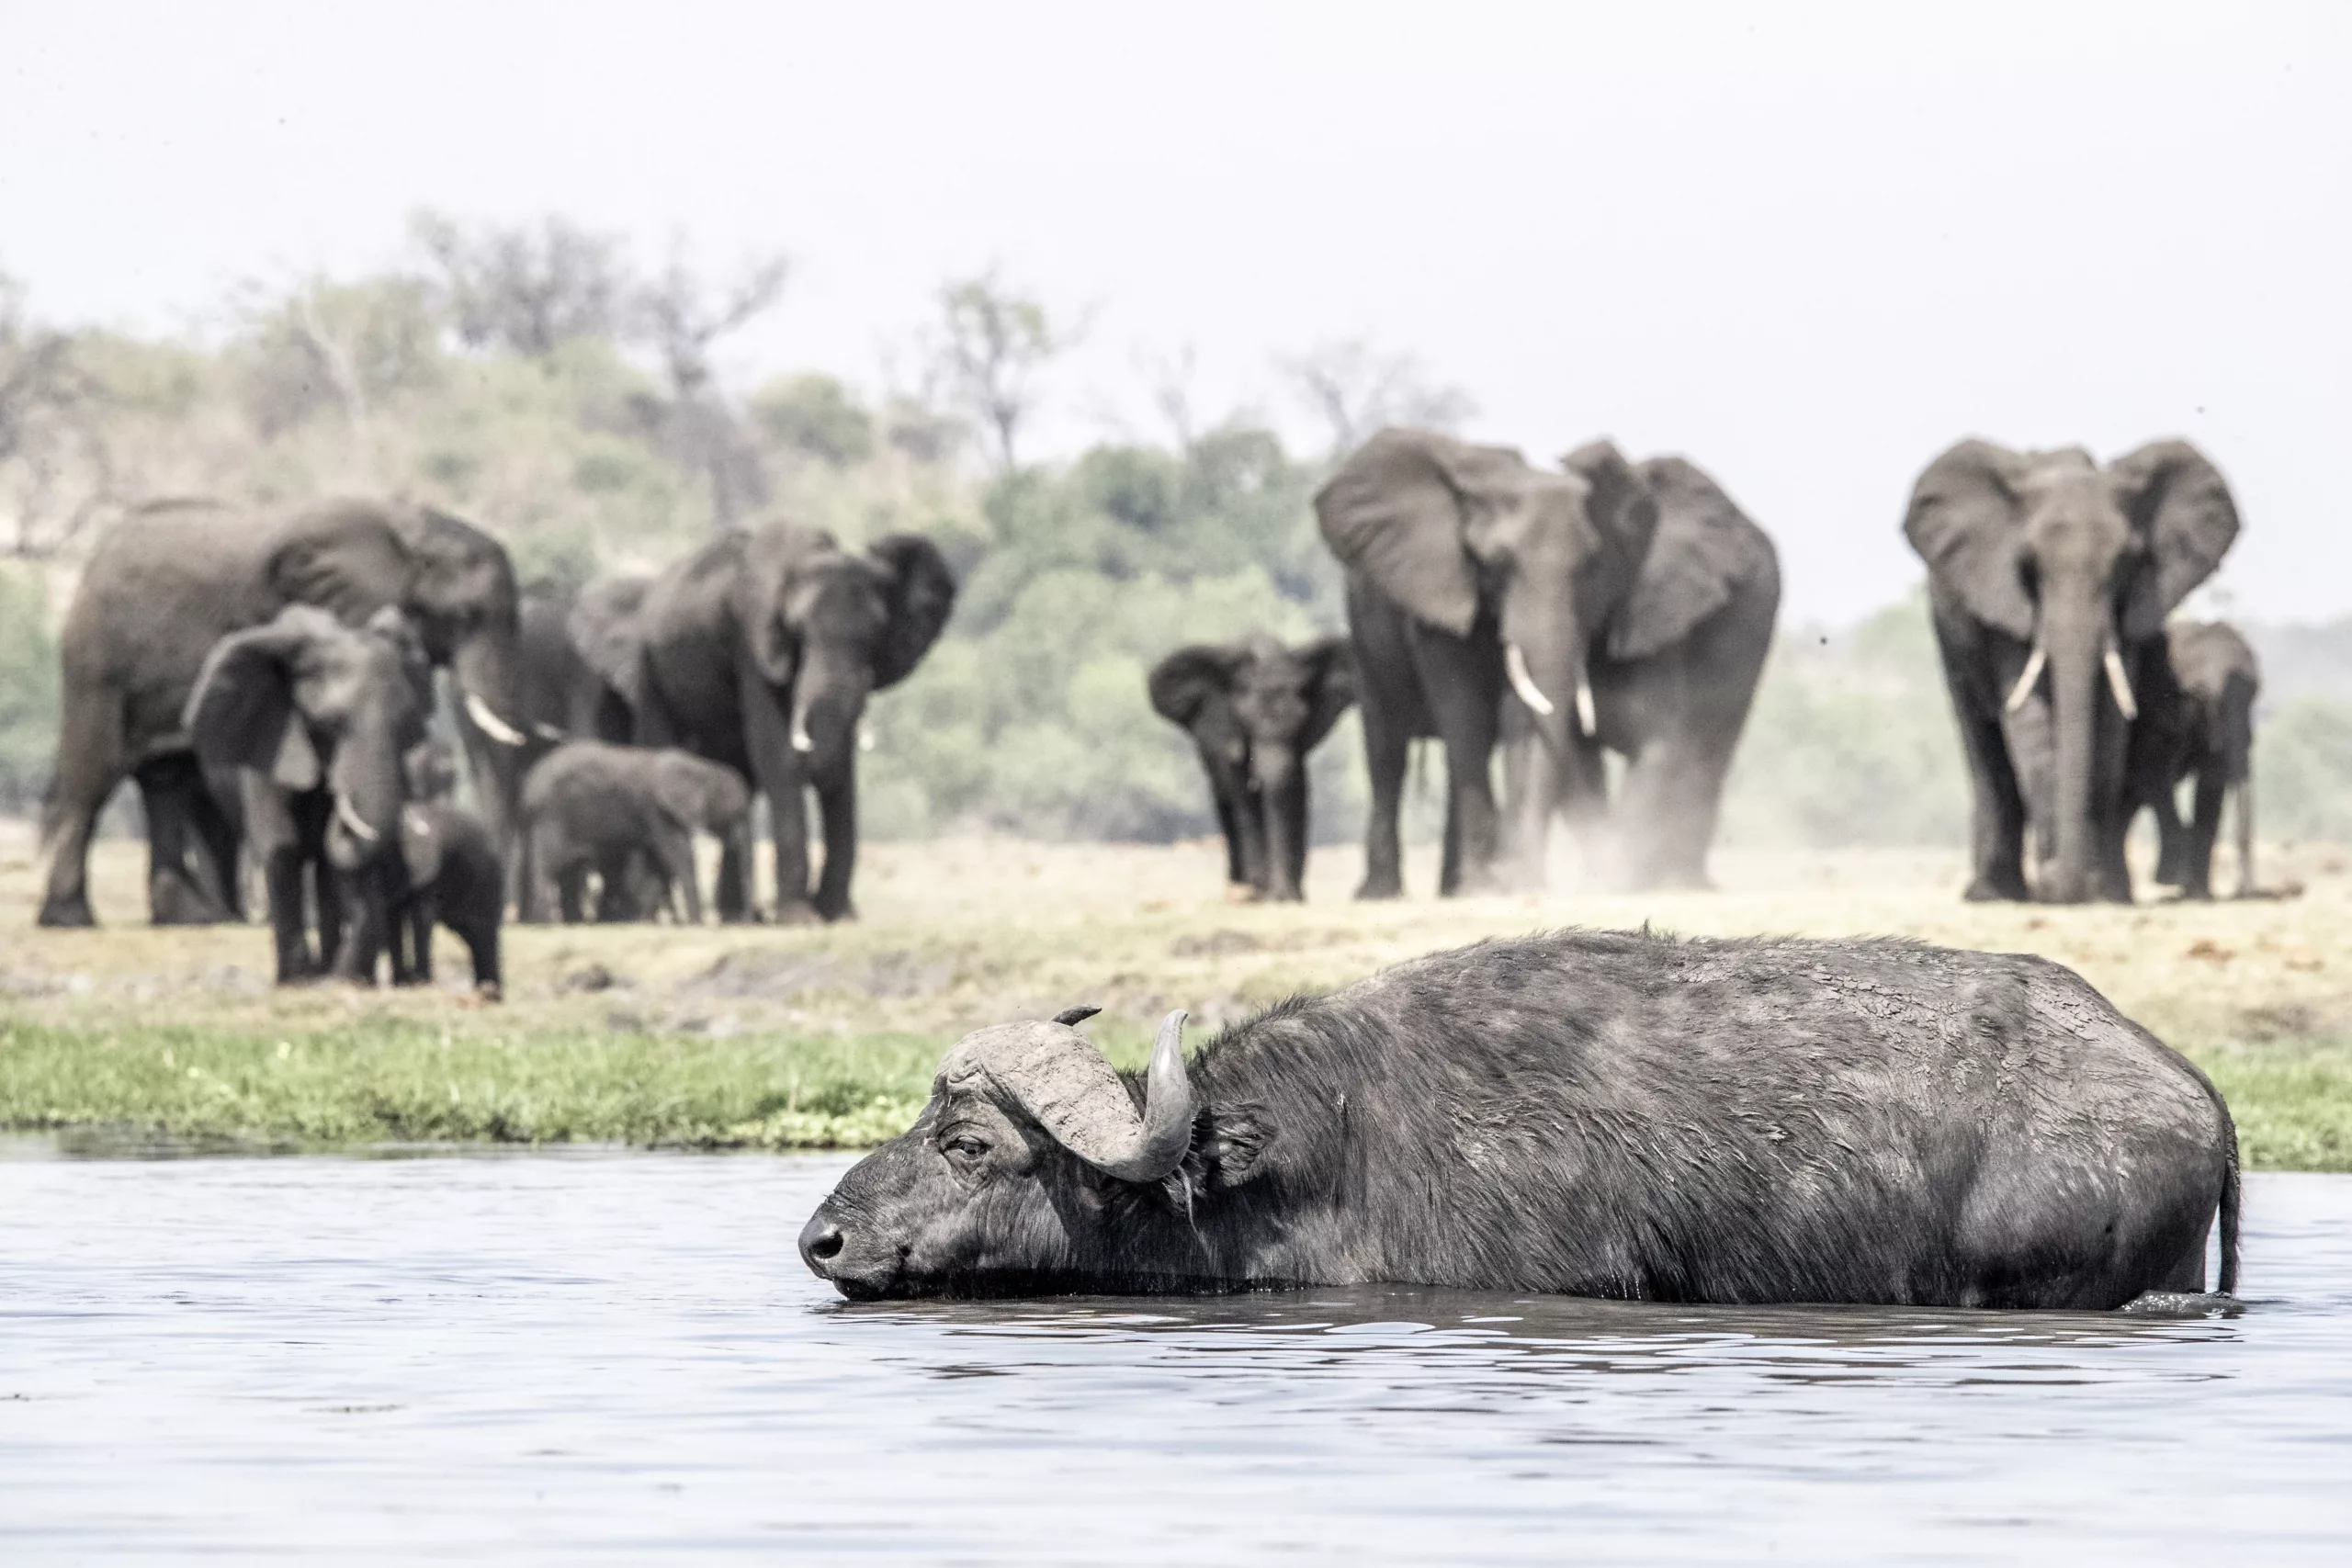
[0,1018,938,1149]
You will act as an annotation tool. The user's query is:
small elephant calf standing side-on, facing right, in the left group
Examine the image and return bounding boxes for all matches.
[522,740,751,924]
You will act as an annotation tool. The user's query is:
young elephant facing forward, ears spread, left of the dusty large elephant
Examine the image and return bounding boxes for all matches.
[1146,632,1355,900]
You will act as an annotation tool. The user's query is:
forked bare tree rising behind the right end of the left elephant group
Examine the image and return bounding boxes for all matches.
[630,244,790,529]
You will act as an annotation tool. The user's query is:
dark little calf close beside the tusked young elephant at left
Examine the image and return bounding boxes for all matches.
[393,740,505,1001]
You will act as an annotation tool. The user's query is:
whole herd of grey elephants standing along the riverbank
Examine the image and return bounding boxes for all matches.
[40,430,2258,992]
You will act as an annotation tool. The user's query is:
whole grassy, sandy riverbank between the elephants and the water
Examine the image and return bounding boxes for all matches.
[0,835,2352,1170]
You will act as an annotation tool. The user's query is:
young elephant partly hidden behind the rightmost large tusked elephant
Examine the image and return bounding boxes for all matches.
[2129,621,2263,898]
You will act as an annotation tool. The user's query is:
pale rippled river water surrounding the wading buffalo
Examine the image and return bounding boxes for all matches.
[0,1143,2352,1565]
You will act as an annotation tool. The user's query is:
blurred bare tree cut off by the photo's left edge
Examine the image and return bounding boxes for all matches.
[0,275,113,559]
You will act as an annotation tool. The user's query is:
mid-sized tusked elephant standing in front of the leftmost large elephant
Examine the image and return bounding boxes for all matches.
[184,604,433,985]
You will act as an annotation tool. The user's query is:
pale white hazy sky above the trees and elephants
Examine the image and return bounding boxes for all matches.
[0,0,2352,618]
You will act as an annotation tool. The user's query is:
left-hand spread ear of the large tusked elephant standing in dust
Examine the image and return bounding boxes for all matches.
[1315,430,1533,637]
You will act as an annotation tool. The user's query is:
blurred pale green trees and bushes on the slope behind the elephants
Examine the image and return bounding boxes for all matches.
[0,214,2352,849]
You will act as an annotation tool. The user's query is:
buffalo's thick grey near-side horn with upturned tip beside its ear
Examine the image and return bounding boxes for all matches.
[938,1010,1193,1182]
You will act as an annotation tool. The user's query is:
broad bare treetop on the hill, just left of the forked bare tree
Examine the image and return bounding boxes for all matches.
[409,211,633,360]
